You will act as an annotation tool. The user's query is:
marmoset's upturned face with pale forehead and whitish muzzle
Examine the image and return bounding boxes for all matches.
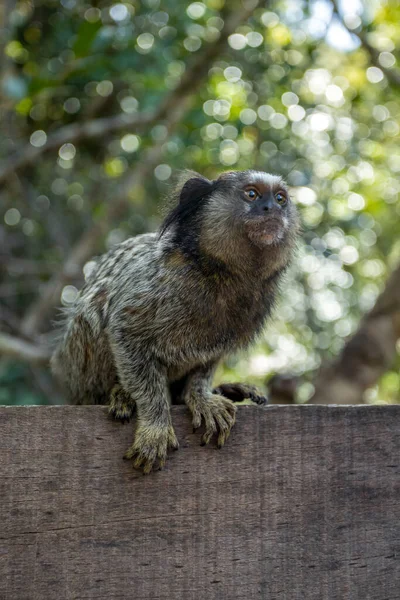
[220,171,296,247]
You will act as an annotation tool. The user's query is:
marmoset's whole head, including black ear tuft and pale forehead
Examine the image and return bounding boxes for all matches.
[161,171,299,272]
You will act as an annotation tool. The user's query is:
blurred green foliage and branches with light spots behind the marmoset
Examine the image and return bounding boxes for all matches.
[0,0,400,404]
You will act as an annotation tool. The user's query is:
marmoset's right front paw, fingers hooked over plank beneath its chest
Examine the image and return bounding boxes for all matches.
[189,394,236,448]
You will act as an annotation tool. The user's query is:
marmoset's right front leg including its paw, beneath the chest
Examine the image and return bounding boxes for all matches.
[183,365,236,448]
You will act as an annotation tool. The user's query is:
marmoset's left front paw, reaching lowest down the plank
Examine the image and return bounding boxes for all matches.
[124,423,179,474]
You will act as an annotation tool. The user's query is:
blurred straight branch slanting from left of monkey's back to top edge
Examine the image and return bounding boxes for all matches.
[21,0,260,336]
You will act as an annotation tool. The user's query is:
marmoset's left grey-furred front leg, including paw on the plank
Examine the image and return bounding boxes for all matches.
[114,346,179,473]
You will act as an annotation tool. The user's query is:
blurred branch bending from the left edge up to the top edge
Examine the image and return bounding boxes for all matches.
[0,0,259,184]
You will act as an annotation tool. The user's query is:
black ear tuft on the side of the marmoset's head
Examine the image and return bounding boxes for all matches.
[160,177,215,237]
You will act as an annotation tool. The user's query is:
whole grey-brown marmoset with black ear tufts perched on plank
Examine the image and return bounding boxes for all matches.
[52,171,299,473]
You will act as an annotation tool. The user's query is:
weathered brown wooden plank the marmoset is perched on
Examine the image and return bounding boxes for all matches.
[0,406,400,600]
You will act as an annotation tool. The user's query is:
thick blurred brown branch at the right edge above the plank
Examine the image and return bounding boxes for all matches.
[310,266,400,404]
